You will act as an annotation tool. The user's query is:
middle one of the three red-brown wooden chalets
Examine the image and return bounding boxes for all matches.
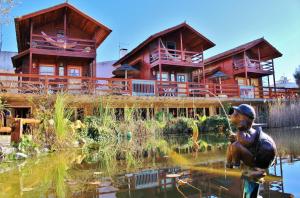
[114,23,215,82]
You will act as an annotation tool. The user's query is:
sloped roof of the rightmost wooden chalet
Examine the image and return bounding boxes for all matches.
[204,38,282,65]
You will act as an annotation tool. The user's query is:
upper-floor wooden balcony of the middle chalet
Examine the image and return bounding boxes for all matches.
[150,48,203,68]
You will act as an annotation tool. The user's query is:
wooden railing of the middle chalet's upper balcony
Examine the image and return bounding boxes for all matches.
[150,48,203,65]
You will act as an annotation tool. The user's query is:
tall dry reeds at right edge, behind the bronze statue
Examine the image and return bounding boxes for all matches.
[268,100,300,128]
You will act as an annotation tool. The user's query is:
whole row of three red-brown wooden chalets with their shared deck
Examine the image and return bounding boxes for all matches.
[0,3,296,121]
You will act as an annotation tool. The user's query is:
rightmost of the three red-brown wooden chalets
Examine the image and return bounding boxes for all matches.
[203,38,282,98]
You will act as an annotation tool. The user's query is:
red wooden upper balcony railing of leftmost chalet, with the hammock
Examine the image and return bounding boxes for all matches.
[30,34,96,53]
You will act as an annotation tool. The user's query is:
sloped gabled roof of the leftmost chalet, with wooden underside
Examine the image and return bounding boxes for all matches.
[15,3,112,51]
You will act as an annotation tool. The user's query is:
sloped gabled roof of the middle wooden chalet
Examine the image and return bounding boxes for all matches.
[114,22,215,66]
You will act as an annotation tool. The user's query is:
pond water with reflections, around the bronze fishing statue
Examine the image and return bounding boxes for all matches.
[0,128,300,198]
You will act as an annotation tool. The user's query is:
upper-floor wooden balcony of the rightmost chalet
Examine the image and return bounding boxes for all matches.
[233,59,274,77]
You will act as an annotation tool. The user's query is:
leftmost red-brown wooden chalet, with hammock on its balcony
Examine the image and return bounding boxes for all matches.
[12,3,111,77]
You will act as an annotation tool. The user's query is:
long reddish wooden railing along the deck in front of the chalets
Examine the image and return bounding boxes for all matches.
[0,73,299,98]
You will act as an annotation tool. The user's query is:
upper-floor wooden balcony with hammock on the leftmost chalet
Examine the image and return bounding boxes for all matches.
[30,34,96,58]
